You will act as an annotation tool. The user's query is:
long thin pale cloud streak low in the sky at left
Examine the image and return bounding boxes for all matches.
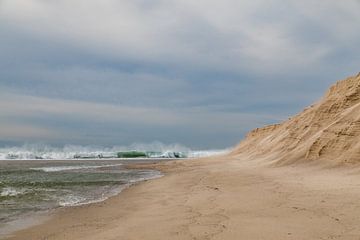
[0,94,187,125]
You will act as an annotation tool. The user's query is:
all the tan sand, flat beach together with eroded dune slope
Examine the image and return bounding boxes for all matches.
[8,69,360,240]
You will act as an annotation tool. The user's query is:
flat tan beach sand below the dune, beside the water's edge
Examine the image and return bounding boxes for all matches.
[4,156,360,240]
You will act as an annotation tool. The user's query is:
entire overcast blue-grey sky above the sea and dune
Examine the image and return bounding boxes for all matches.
[0,0,360,149]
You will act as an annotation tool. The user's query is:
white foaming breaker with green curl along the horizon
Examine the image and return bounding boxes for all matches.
[0,142,228,160]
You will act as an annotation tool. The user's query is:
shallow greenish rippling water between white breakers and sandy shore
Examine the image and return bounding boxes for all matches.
[0,160,162,235]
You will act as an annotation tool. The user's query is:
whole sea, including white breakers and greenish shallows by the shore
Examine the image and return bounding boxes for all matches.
[0,143,228,239]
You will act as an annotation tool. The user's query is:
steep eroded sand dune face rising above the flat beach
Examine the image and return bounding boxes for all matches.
[232,73,360,164]
